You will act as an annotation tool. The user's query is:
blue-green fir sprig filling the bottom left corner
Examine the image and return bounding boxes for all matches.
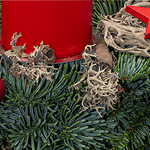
[0,105,56,150]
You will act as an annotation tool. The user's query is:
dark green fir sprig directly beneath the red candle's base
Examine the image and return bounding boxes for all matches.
[0,58,83,107]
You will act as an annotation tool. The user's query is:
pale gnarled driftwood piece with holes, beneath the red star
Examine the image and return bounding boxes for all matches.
[97,0,150,57]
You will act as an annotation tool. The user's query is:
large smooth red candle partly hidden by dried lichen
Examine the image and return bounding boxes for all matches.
[1,0,92,59]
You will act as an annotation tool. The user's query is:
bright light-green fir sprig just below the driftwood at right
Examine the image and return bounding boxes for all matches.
[113,52,150,83]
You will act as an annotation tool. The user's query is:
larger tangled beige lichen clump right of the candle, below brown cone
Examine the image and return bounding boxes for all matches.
[69,45,121,117]
